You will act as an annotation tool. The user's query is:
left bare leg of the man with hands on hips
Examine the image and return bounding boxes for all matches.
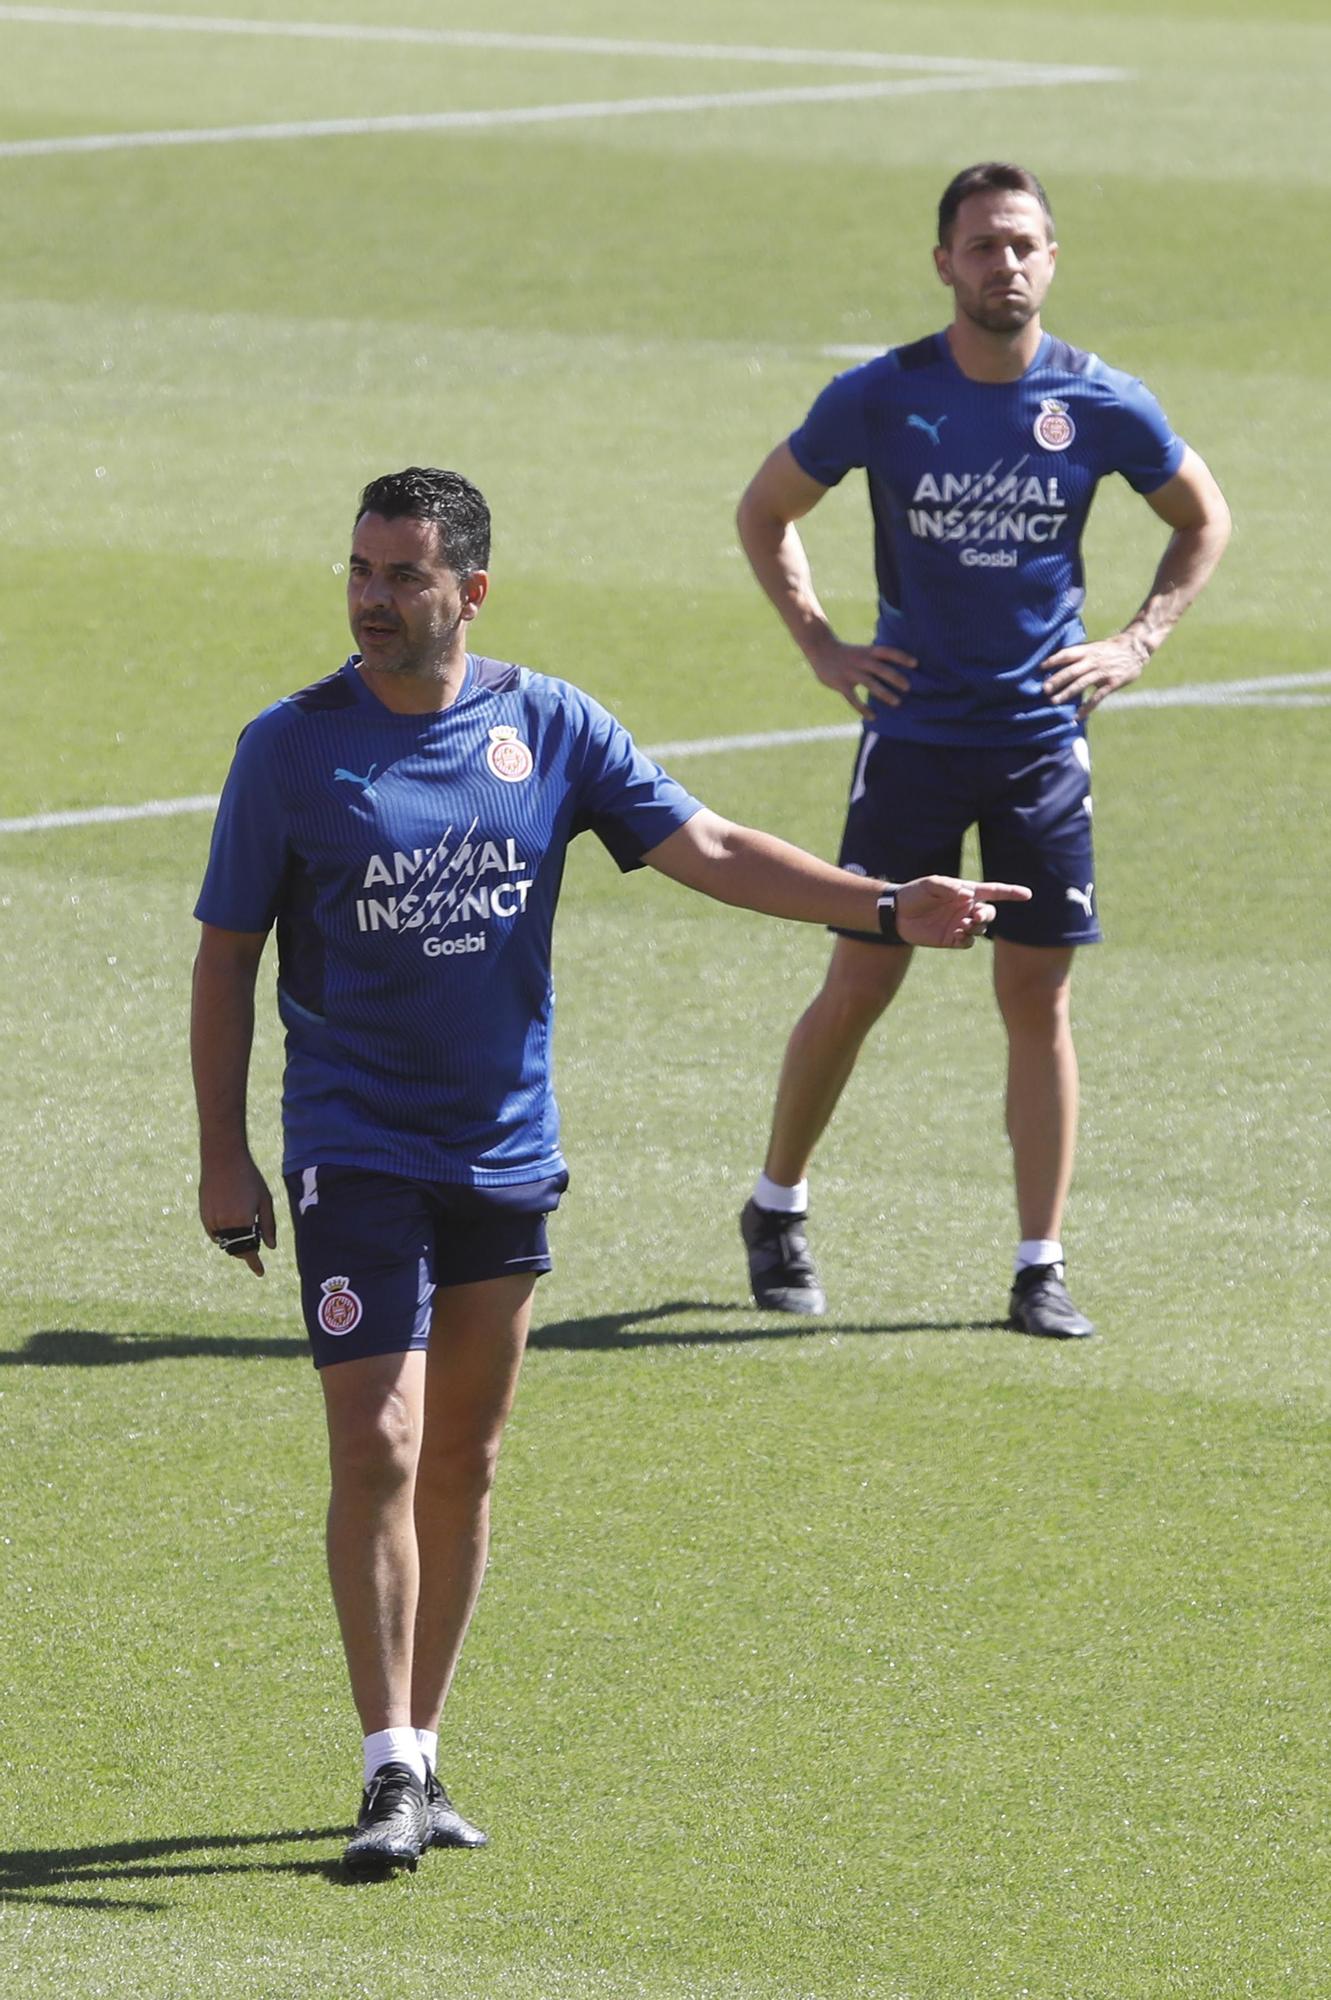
[765,938,911,1188]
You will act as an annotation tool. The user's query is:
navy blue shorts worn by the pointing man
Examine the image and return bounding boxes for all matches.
[286,1166,568,1368]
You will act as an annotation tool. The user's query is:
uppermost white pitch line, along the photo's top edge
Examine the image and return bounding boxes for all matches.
[0,6,1131,82]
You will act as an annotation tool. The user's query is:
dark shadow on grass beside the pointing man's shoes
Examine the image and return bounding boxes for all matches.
[0,1826,348,1912]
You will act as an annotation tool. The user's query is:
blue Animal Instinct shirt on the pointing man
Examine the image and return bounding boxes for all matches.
[194,654,699,1188]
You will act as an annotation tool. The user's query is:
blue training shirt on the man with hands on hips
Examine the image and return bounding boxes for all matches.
[789,334,1185,746]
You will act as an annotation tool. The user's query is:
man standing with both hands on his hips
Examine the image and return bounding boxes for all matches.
[739,162,1229,1338]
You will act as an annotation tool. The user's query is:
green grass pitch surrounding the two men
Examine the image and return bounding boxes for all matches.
[0,0,1331,2000]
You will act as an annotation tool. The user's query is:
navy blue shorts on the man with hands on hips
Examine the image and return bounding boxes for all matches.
[839,730,1101,944]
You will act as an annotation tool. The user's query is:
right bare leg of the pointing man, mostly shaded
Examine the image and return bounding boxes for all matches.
[410,1274,536,1730]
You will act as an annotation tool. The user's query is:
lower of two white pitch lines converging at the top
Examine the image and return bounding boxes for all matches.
[0,70,1119,160]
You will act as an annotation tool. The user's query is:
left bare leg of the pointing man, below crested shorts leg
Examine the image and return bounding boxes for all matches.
[320,1352,426,1736]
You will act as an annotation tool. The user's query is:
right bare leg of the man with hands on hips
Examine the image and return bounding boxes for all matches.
[993,938,1077,1242]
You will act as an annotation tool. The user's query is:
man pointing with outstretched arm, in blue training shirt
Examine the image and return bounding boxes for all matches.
[190,468,1027,1872]
